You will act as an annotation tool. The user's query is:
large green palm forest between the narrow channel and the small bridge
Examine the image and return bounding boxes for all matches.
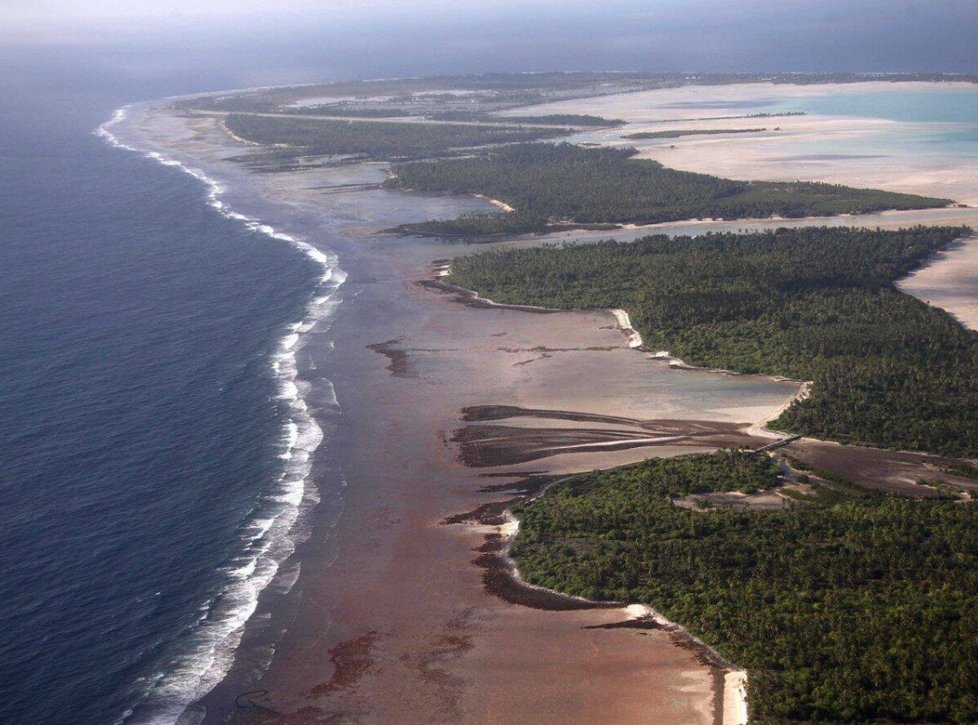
[448,227,978,456]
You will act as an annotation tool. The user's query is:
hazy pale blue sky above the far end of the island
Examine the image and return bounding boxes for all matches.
[0,0,978,86]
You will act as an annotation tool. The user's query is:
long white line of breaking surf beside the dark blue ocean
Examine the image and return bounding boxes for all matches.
[95,104,346,719]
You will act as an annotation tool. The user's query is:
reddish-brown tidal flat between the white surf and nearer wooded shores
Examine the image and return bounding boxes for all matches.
[212,268,764,723]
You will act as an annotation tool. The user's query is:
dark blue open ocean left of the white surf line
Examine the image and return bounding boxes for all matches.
[0,52,322,725]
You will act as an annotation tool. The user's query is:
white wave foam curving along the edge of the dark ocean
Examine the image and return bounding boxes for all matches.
[95,106,346,723]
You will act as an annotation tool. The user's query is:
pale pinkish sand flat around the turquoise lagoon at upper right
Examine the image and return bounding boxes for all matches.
[508,82,978,205]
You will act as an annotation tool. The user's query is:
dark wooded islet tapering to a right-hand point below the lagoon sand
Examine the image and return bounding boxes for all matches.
[387,143,950,234]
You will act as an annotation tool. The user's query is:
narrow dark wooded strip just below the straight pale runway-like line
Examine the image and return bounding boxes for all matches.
[225,114,566,160]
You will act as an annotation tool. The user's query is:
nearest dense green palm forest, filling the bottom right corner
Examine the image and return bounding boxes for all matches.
[512,452,978,723]
